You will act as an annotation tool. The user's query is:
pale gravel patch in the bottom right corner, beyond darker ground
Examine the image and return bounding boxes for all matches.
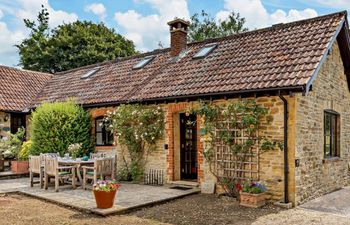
[252,208,350,225]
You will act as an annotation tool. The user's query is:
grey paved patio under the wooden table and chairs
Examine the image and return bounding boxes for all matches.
[0,178,200,216]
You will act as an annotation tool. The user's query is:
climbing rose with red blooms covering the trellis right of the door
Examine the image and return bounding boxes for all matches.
[194,100,283,197]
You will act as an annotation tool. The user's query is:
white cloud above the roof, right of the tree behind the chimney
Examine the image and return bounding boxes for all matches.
[216,0,317,29]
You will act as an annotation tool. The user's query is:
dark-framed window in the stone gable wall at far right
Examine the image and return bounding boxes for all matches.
[323,110,340,159]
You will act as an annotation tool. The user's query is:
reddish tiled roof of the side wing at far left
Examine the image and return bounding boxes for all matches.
[0,66,52,111]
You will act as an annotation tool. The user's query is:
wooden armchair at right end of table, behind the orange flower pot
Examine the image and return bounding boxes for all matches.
[82,157,115,190]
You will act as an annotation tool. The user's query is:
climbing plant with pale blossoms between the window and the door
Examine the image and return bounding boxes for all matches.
[103,104,164,182]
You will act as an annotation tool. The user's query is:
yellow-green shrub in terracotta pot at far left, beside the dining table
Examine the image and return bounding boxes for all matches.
[7,128,31,173]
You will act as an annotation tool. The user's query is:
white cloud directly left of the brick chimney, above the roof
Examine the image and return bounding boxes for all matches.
[114,0,190,51]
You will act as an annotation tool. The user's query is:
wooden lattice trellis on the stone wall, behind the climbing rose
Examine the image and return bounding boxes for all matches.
[215,122,259,180]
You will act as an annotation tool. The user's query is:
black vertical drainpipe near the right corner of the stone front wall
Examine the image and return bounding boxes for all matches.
[279,95,289,203]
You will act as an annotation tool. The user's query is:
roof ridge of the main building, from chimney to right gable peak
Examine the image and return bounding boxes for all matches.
[187,10,347,46]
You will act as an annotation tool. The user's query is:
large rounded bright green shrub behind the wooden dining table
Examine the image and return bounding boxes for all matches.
[30,100,93,157]
